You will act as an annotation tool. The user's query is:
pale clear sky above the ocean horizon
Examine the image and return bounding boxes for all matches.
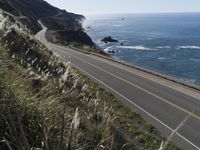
[46,0,200,15]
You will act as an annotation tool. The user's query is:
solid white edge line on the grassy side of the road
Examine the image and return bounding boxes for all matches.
[73,64,200,150]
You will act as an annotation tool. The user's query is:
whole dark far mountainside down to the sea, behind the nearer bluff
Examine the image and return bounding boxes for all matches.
[0,0,84,34]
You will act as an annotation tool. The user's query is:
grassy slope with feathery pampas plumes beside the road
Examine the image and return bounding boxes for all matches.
[0,26,179,150]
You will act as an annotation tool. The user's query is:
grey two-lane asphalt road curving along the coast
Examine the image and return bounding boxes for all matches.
[36,28,200,150]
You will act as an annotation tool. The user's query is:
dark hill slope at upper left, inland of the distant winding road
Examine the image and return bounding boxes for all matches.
[0,0,59,34]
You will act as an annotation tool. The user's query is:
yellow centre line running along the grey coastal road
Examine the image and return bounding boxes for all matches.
[70,54,200,121]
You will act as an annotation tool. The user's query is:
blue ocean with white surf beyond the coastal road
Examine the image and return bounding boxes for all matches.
[85,13,200,84]
